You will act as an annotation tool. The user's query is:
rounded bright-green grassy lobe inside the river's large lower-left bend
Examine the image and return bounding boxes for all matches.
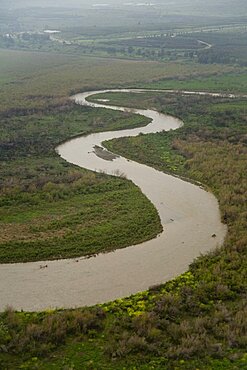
[0,158,161,262]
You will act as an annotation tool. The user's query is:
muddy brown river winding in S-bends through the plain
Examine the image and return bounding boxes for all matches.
[0,90,226,311]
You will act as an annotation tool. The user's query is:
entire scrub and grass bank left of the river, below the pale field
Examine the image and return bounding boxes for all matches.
[0,98,164,262]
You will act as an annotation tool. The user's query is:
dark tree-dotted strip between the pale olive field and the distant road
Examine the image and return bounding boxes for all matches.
[0,25,247,67]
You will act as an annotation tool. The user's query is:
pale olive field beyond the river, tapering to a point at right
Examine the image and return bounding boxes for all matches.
[0,49,237,112]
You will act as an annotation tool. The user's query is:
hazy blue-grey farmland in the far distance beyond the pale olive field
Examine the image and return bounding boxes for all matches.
[0,0,247,66]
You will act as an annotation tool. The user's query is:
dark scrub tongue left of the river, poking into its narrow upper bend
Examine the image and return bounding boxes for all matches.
[0,103,149,160]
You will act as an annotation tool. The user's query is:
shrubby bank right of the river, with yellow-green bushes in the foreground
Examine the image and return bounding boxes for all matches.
[0,93,247,370]
